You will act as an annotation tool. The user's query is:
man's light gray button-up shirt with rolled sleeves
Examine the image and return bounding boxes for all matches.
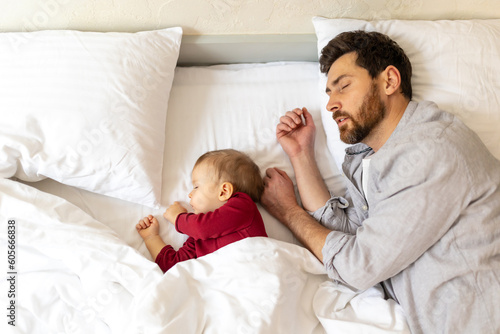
[312,101,500,333]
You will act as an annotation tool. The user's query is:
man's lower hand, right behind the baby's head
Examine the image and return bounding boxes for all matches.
[261,168,300,225]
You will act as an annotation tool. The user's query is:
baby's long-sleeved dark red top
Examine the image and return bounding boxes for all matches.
[155,192,267,272]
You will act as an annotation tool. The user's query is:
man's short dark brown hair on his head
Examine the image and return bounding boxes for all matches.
[319,30,412,100]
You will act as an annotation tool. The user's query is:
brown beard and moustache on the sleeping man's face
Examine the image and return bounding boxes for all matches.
[333,81,386,144]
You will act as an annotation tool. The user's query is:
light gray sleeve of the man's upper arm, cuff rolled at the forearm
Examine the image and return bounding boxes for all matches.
[323,137,471,290]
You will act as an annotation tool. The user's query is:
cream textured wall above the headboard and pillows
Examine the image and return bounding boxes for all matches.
[0,0,500,35]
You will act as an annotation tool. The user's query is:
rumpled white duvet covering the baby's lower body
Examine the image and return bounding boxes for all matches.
[0,180,409,334]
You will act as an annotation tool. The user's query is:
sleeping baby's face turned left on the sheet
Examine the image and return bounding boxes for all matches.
[189,163,224,214]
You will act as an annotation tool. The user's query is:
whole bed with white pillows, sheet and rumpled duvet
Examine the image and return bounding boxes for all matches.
[0,17,500,334]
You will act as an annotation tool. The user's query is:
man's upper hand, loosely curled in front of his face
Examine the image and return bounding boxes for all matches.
[276,108,316,159]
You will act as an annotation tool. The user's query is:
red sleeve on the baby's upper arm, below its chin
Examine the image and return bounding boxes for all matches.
[175,193,255,240]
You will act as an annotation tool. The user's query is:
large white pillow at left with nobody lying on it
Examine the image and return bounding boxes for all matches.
[0,27,182,207]
